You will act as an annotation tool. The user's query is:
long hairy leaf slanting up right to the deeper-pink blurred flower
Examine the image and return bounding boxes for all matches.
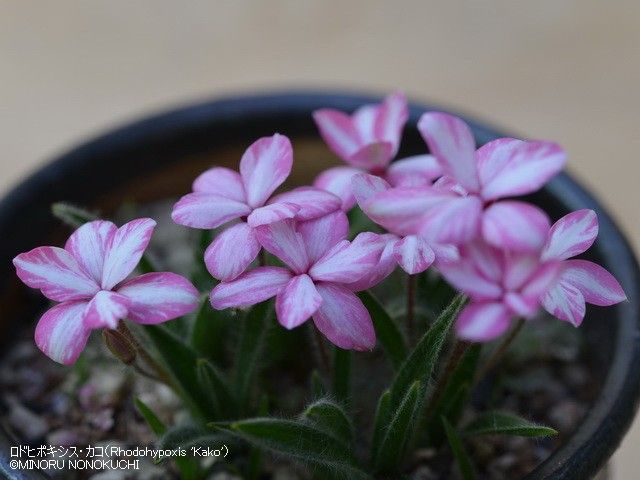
[391,295,466,410]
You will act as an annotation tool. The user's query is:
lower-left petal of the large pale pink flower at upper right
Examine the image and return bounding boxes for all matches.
[420,196,482,245]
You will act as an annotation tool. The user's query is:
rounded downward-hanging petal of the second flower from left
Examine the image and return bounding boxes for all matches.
[204,222,261,282]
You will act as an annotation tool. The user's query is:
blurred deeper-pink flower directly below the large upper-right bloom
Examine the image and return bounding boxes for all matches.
[438,244,560,342]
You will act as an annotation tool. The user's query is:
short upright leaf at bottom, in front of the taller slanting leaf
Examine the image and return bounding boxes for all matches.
[373,382,420,472]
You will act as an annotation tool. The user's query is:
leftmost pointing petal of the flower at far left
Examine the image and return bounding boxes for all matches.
[13,247,99,302]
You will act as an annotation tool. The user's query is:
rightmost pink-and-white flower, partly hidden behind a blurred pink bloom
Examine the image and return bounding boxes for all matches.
[542,210,627,327]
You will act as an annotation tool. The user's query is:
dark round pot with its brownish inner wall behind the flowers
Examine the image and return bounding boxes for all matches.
[0,92,640,480]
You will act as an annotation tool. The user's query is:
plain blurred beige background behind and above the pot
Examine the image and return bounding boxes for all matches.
[0,0,640,480]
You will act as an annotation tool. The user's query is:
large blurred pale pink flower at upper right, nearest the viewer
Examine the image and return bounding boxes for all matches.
[410,112,565,251]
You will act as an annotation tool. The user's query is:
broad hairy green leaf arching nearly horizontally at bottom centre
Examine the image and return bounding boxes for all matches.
[214,418,370,480]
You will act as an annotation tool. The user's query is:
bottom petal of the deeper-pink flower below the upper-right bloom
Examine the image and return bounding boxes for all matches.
[456,302,510,342]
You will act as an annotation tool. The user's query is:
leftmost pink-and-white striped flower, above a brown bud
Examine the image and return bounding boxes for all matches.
[13,218,199,364]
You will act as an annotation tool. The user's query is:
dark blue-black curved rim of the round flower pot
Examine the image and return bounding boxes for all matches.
[0,90,640,480]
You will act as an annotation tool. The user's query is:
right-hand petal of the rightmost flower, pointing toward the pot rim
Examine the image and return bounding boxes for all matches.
[560,260,627,307]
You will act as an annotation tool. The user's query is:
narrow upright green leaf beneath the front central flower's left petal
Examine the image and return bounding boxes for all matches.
[234,301,273,412]
